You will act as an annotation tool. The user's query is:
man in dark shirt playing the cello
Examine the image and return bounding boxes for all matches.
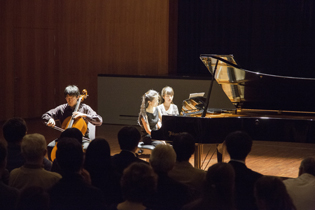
[42,85,103,156]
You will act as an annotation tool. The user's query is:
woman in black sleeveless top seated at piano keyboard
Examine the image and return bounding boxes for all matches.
[138,90,164,146]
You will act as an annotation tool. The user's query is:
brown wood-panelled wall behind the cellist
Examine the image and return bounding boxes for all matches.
[0,0,177,120]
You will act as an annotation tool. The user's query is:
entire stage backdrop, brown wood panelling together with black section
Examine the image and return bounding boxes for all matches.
[0,0,315,120]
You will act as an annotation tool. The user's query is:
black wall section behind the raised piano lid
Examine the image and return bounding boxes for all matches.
[178,0,315,77]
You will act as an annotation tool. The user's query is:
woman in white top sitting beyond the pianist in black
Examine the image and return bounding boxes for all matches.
[158,86,179,115]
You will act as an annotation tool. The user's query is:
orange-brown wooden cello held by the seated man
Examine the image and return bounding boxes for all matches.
[50,89,90,161]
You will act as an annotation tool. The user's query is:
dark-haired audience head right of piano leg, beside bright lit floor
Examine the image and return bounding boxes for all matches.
[225,131,253,160]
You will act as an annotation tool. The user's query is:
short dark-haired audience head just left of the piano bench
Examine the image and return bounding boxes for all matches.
[118,126,141,151]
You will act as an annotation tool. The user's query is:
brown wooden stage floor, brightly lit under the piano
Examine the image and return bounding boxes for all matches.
[0,119,315,178]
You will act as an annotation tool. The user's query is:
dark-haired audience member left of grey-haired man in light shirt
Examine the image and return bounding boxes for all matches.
[3,117,51,172]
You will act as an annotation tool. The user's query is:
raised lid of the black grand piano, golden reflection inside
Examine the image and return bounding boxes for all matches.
[200,54,315,113]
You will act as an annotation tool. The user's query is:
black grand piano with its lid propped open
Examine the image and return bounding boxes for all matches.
[151,54,315,167]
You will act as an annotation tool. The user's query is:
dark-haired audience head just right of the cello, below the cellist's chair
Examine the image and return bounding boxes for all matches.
[84,138,111,171]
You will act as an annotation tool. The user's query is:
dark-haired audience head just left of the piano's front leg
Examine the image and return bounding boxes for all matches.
[173,133,195,162]
